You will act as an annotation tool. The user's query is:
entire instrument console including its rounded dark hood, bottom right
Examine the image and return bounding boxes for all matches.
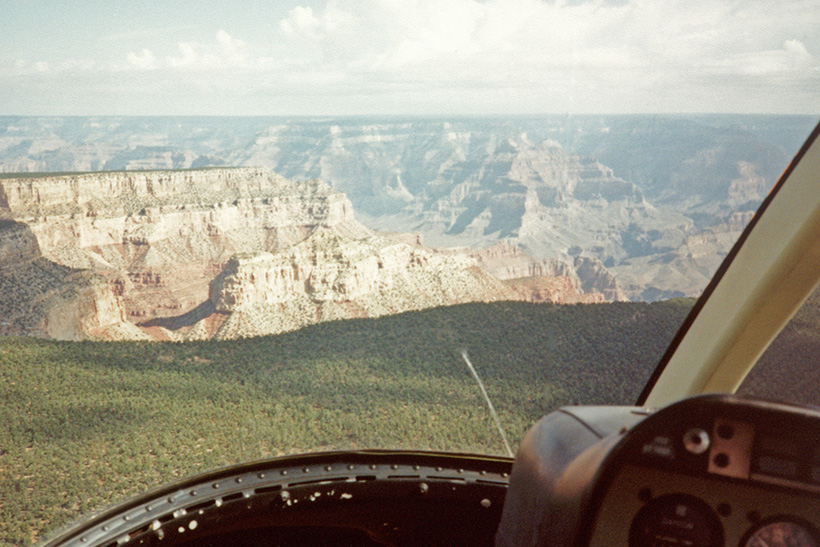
[497,396,820,547]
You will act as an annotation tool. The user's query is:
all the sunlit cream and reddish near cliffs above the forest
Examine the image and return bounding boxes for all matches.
[0,168,604,340]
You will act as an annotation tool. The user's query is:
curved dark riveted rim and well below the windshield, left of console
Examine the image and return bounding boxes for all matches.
[38,450,512,547]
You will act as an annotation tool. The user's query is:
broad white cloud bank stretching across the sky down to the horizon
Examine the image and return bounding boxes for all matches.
[6,0,820,113]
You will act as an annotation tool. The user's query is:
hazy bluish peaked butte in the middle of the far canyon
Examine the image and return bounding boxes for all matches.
[369,134,658,258]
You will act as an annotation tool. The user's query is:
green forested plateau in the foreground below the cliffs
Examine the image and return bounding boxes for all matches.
[0,300,692,546]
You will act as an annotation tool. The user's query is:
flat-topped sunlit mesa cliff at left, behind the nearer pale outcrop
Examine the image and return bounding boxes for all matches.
[0,168,370,330]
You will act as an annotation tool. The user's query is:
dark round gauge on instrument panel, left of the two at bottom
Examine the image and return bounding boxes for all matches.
[629,494,723,547]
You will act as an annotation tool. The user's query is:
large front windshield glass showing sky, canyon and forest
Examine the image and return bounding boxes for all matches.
[0,0,820,546]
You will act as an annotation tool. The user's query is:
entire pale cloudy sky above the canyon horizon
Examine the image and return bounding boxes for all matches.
[0,0,820,116]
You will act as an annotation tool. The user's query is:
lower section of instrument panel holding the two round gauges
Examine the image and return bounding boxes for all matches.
[590,466,820,547]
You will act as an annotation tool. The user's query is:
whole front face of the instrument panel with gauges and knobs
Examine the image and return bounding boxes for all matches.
[589,401,820,547]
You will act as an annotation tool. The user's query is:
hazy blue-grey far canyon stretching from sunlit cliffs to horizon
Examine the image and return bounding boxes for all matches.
[0,115,816,302]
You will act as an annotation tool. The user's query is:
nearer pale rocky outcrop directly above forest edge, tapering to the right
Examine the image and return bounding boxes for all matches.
[194,229,604,338]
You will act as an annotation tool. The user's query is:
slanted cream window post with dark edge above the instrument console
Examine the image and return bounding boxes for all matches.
[636,123,820,406]
